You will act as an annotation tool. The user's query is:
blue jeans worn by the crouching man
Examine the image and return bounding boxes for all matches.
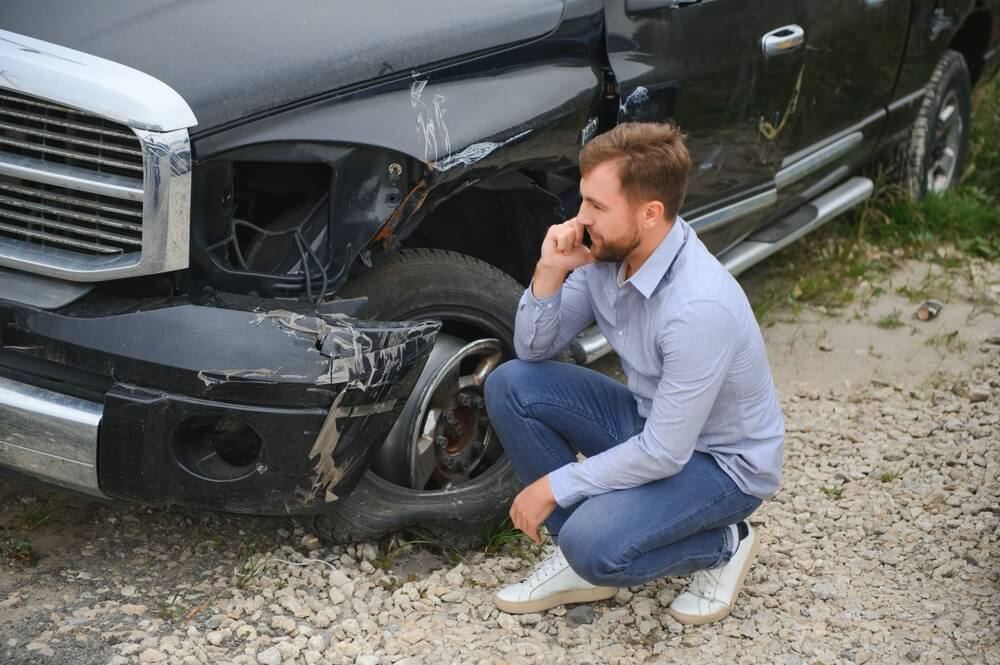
[486,360,761,587]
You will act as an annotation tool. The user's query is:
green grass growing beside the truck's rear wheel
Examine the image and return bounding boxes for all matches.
[744,72,1000,322]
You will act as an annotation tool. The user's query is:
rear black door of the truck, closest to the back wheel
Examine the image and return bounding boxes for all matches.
[764,0,920,214]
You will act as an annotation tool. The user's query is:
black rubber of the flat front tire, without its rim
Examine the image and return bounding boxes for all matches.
[312,249,524,546]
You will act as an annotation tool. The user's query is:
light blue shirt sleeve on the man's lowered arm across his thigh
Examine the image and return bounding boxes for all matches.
[549,300,739,508]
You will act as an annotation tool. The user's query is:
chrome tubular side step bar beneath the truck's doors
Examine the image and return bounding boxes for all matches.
[569,177,875,365]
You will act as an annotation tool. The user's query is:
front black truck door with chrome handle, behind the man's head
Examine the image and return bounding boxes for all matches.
[605,0,805,252]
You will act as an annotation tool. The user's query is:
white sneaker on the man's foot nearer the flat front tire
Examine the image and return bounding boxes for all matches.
[493,547,618,614]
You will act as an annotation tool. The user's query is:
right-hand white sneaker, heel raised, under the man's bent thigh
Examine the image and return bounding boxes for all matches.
[667,524,760,624]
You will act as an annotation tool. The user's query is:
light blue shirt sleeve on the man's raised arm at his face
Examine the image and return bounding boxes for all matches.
[514,266,594,360]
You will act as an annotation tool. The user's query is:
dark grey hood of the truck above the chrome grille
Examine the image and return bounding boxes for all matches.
[0,0,563,133]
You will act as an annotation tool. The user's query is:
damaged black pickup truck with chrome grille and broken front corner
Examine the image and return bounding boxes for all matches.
[0,0,1000,539]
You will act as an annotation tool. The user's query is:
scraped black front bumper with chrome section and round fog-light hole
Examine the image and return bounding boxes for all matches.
[0,294,440,514]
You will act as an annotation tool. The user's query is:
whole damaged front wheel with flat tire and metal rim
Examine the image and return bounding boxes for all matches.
[312,249,524,544]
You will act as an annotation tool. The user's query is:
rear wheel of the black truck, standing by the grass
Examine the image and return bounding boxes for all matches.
[903,50,972,200]
